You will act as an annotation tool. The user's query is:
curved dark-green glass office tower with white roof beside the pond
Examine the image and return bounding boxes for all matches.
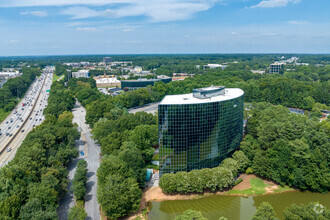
[158,86,244,175]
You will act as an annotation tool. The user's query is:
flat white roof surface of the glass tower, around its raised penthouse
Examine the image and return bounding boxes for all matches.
[159,86,244,105]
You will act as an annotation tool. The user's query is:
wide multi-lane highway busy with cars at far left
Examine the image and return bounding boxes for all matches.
[0,66,54,167]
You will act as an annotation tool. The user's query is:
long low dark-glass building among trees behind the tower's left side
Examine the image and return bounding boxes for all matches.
[121,77,172,90]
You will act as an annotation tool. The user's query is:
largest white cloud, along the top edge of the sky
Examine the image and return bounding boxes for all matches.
[0,0,223,22]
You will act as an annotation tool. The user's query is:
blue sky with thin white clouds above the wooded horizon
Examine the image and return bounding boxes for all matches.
[0,0,330,56]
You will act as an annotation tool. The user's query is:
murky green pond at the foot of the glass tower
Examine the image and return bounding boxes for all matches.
[148,191,330,220]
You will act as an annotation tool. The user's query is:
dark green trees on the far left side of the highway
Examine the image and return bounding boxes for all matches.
[0,67,40,122]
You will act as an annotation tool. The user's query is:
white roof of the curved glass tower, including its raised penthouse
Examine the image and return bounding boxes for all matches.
[159,86,244,105]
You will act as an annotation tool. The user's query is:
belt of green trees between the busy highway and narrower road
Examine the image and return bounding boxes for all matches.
[0,82,79,220]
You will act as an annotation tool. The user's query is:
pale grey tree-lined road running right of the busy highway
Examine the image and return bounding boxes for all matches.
[72,102,100,220]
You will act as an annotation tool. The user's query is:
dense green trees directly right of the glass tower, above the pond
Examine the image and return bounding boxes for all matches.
[241,103,330,192]
